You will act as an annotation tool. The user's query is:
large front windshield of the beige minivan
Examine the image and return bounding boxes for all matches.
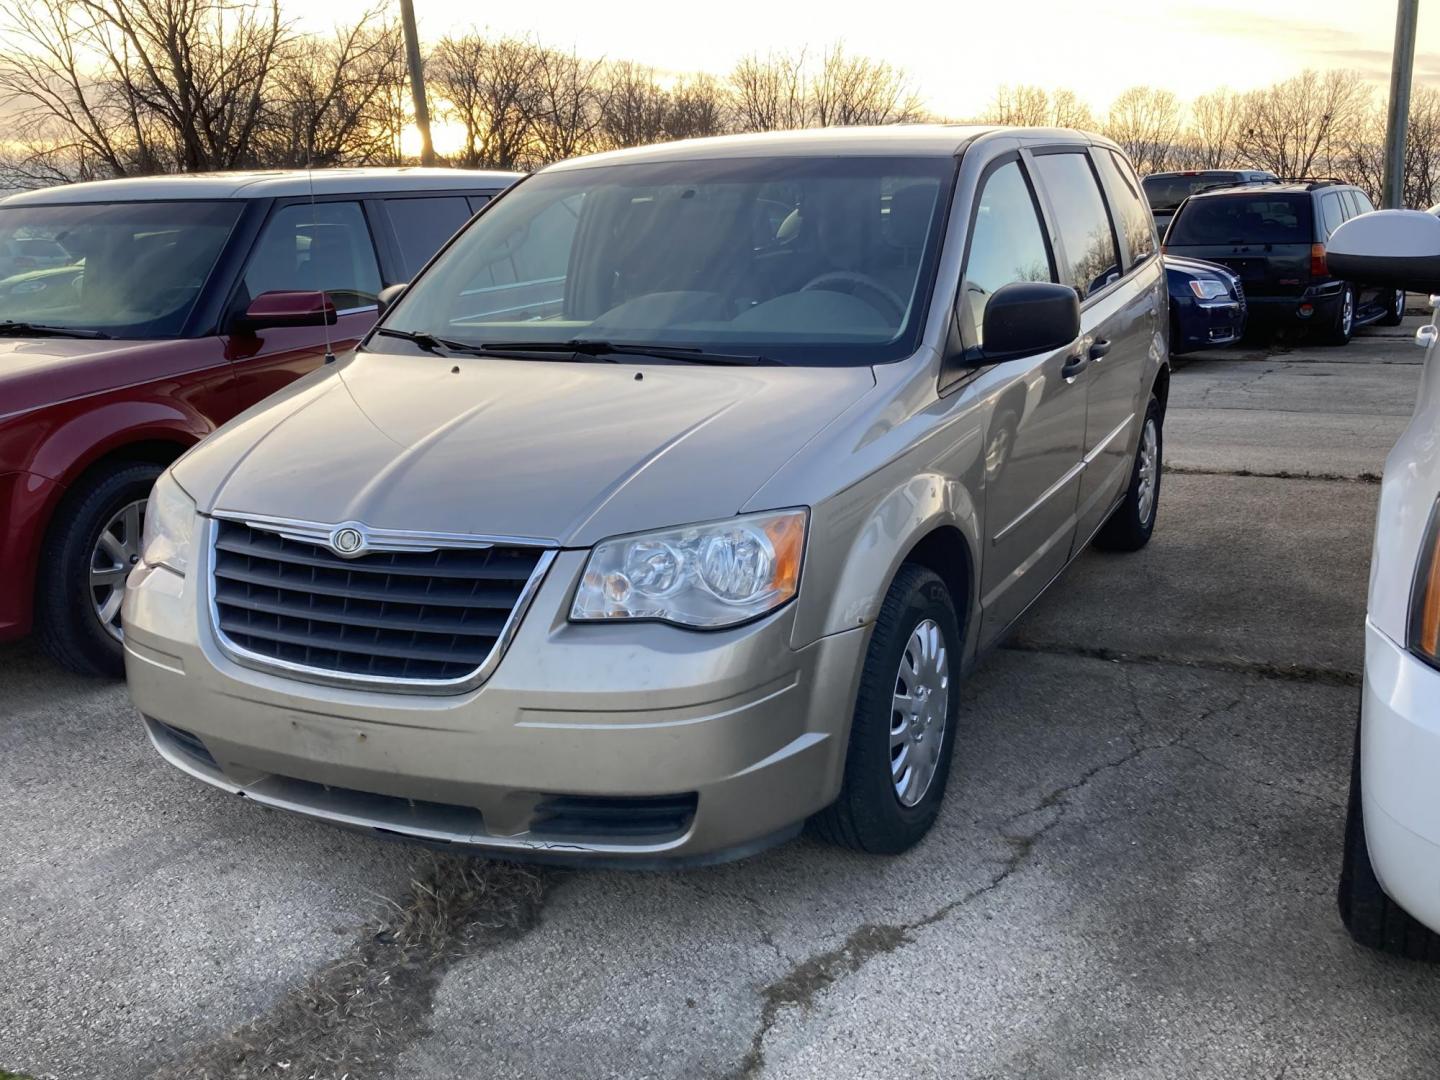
[380,157,955,364]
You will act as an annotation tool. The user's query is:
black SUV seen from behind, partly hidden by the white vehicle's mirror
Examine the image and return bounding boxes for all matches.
[1165,180,1405,346]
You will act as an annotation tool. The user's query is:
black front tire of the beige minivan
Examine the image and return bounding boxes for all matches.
[811,563,963,855]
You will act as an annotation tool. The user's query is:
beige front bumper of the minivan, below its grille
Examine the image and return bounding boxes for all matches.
[124,552,868,861]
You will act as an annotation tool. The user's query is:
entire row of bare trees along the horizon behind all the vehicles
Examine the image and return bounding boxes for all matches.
[0,0,1440,206]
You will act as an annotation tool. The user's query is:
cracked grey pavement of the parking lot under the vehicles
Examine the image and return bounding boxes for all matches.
[0,318,1440,1080]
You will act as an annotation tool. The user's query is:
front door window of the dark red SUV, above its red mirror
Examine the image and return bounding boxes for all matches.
[245,203,380,311]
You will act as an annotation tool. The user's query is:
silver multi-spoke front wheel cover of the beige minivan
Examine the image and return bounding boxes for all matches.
[890,619,950,806]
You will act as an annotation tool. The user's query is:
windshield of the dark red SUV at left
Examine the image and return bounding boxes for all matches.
[0,200,242,338]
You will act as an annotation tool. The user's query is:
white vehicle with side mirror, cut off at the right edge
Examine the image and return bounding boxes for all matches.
[1329,210,1440,960]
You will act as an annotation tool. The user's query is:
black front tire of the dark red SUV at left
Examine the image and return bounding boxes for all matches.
[36,461,163,677]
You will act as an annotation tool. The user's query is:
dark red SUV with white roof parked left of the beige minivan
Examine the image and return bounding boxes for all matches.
[0,168,517,675]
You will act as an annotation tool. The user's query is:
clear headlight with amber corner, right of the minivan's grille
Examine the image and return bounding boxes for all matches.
[570,510,808,628]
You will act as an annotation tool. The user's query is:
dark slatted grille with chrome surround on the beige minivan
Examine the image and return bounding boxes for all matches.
[210,518,552,690]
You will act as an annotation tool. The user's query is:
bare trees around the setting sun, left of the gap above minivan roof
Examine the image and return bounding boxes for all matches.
[0,0,923,186]
